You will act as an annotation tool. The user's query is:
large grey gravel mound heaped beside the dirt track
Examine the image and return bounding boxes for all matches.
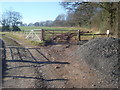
[76,38,120,77]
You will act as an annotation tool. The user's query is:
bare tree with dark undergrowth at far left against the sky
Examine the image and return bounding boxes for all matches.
[0,10,22,31]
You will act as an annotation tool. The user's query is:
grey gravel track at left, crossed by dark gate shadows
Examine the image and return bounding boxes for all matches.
[3,37,68,88]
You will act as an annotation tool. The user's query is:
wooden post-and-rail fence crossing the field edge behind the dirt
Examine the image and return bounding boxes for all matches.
[16,29,109,41]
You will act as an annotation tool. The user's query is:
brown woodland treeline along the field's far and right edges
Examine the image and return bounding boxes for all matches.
[29,0,120,35]
